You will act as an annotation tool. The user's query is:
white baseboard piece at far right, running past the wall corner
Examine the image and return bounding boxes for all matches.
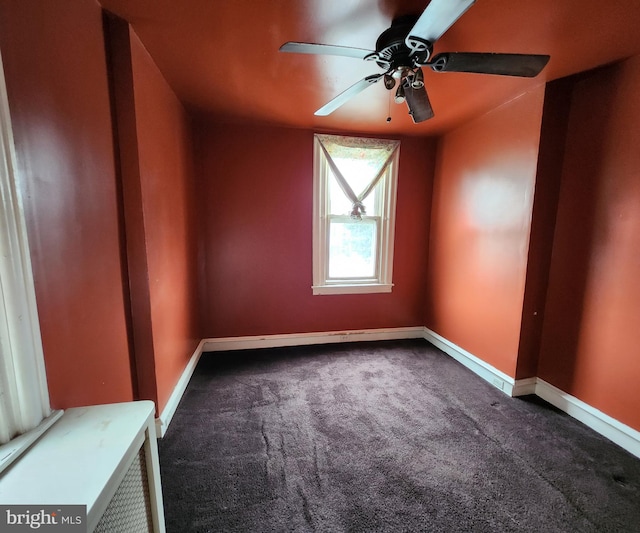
[536,378,640,457]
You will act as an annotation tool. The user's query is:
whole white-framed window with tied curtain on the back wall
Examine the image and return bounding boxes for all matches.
[313,135,400,294]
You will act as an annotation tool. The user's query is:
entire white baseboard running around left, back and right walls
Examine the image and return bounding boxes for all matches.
[156,326,640,457]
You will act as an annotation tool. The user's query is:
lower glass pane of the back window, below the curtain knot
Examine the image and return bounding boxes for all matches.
[329,220,377,279]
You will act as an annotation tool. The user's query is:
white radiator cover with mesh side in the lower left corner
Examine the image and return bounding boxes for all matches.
[0,401,165,533]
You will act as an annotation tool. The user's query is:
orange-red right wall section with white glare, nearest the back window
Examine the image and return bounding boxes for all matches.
[425,87,544,376]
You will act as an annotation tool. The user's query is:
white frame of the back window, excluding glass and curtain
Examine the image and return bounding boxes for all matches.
[312,135,400,294]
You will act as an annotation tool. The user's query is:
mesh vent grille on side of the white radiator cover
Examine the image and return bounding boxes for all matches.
[94,449,153,533]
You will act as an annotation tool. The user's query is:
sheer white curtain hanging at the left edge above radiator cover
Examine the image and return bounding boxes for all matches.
[0,51,51,444]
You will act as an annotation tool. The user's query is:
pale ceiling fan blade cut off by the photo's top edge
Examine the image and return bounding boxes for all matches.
[405,0,475,52]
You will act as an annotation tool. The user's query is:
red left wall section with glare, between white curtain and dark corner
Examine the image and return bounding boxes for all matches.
[0,0,133,408]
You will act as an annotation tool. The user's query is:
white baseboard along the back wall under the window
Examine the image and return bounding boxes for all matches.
[202,326,424,352]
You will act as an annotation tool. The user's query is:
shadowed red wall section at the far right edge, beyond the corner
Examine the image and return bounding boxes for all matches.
[538,56,640,430]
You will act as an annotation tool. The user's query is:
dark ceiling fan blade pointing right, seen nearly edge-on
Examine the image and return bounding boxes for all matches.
[428,52,549,78]
